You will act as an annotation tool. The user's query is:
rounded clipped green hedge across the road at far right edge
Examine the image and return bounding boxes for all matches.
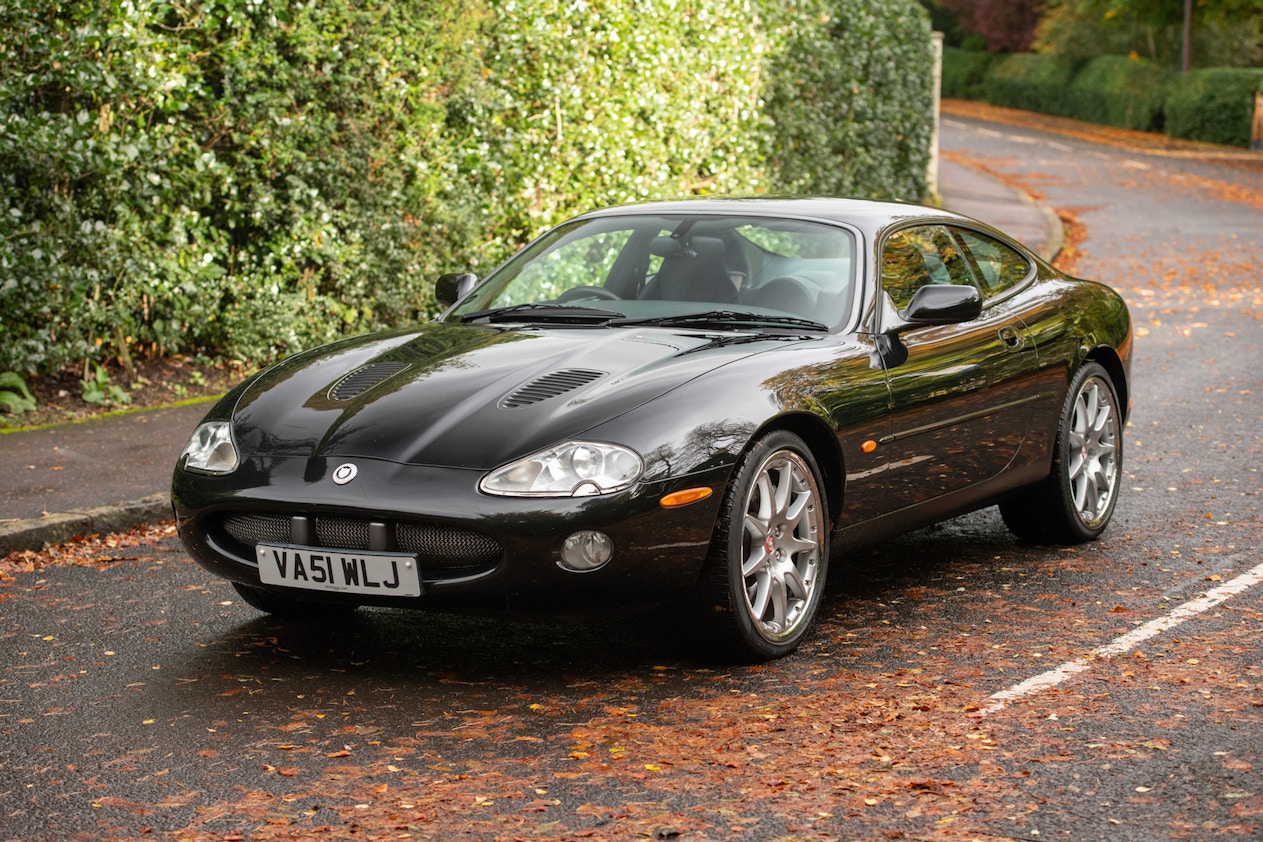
[1164,68,1263,146]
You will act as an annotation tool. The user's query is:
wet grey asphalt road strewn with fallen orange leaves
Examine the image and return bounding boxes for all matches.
[0,117,1263,841]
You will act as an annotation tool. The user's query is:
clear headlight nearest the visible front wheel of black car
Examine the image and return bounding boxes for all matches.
[479,442,644,497]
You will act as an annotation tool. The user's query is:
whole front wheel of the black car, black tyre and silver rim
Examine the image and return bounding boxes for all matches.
[700,432,829,660]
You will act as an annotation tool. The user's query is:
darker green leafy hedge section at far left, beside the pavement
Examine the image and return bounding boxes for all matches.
[0,0,477,371]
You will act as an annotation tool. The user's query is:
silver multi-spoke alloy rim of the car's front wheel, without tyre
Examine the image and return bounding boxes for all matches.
[740,451,825,643]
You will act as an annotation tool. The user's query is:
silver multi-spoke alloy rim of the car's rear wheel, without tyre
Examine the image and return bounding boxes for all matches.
[1066,377,1120,526]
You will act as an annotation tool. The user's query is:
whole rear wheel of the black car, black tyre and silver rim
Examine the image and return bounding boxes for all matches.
[1000,362,1123,544]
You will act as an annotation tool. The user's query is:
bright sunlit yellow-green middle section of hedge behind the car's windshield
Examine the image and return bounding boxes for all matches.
[460,0,770,254]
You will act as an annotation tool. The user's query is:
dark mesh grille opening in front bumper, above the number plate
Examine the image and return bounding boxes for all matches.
[222,513,504,571]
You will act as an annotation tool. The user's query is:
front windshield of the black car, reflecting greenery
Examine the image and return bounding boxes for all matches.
[447,215,855,329]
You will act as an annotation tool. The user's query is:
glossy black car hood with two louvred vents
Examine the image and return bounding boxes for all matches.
[224,322,784,470]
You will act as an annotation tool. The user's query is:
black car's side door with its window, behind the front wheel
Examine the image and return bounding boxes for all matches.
[880,225,1038,505]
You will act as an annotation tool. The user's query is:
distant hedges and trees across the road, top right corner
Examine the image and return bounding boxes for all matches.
[926,0,1263,146]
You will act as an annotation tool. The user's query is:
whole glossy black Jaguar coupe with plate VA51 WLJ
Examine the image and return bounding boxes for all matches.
[172,198,1132,658]
